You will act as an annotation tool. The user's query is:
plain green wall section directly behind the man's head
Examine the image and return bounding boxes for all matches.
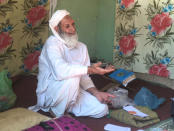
[57,0,99,56]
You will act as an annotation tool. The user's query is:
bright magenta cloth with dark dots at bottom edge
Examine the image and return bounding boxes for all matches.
[24,116,92,131]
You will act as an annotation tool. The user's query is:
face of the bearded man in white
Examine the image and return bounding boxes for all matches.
[58,15,76,36]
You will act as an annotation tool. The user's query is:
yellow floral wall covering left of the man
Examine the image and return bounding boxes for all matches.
[0,0,49,76]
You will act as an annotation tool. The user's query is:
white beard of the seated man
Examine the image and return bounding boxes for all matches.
[61,33,78,49]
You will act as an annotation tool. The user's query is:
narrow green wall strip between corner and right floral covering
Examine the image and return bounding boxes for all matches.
[95,0,115,62]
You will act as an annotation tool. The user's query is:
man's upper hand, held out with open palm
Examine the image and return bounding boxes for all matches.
[88,62,115,75]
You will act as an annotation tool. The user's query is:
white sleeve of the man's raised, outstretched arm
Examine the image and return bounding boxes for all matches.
[42,37,88,80]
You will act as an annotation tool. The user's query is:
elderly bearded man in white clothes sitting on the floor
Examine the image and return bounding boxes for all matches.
[29,10,114,118]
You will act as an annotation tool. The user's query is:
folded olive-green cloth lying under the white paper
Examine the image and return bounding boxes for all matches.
[110,106,160,128]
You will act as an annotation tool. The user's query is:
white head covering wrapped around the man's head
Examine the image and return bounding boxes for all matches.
[49,10,70,42]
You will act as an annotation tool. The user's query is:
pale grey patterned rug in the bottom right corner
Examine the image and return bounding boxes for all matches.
[144,118,174,131]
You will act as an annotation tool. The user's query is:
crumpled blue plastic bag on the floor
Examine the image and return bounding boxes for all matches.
[134,87,165,109]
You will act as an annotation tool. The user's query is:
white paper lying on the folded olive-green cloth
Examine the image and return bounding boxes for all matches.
[123,106,149,117]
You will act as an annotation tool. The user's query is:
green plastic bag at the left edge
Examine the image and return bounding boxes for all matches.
[0,70,16,111]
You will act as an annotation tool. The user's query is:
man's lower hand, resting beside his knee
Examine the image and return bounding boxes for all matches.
[87,87,116,104]
